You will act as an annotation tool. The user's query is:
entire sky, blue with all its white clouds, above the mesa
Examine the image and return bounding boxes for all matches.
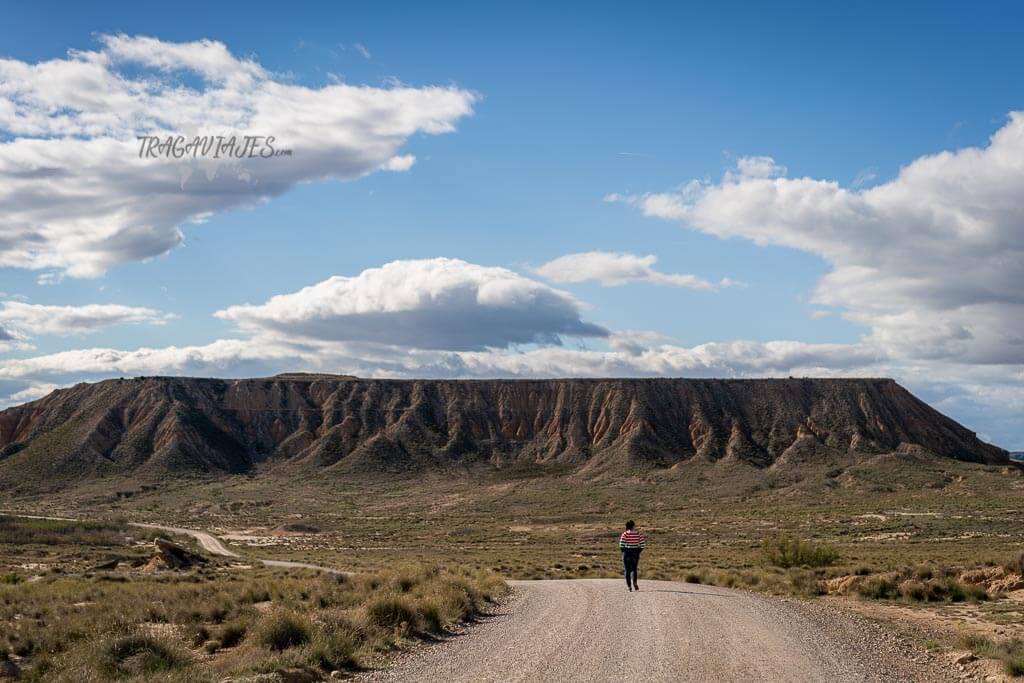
[0,2,1024,450]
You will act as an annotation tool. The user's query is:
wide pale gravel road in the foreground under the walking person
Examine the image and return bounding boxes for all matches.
[360,579,955,683]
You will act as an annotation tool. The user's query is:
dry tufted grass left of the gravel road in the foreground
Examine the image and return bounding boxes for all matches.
[0,565,505,681]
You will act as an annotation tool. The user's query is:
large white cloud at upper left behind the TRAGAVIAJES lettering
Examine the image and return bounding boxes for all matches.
[0,35,476,278]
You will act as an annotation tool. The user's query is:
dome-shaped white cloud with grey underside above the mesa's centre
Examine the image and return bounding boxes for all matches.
[215,258,608,350]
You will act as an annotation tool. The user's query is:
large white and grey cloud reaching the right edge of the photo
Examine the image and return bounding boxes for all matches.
[609,120,1024,366]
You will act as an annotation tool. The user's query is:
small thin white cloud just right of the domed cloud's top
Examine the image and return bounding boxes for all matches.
[534,251,737,290]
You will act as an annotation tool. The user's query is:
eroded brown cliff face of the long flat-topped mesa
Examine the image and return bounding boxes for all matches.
[0,375,1009,480]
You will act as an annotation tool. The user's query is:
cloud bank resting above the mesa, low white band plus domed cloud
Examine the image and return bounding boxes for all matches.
[0,253,1024,446]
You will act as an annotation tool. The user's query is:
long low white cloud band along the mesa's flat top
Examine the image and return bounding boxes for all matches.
[0,333,885,381]
